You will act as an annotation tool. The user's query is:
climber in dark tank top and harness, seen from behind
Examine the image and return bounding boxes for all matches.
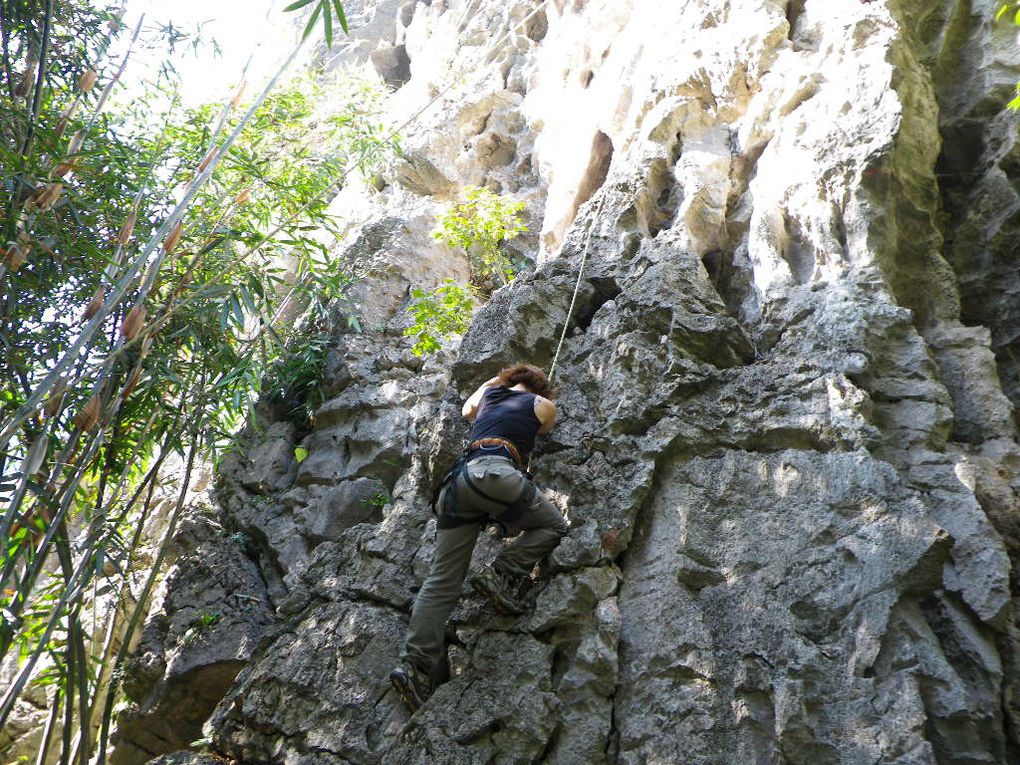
[390,364,568,712]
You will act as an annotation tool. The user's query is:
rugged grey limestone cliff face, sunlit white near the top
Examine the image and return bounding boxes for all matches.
[125,0,1020,765]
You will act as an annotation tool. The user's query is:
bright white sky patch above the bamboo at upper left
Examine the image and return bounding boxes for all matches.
[114,0,297,106]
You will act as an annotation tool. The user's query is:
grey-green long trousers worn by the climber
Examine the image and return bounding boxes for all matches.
[403,455,568,671]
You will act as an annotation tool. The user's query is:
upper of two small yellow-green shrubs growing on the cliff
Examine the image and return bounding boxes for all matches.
[432,186,527,288]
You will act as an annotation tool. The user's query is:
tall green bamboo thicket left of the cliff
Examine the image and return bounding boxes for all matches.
[0,0,398,761]
